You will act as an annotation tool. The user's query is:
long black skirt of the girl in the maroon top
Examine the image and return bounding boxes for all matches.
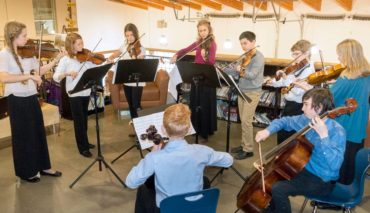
[190,84,217,138]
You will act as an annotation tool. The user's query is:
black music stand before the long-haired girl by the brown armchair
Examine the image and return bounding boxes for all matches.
[111,59,159,164]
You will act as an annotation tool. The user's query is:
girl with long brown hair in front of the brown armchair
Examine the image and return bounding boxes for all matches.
[108,23,145,121]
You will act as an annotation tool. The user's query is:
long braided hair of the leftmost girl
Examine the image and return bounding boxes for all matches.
[4,21,26,74]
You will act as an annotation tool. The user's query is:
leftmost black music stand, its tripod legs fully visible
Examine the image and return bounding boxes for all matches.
[68,64,126,188]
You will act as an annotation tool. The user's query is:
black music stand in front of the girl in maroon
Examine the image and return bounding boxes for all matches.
[176,61,221,143]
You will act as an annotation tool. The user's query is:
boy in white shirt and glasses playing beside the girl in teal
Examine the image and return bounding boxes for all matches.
[268,40,315,144]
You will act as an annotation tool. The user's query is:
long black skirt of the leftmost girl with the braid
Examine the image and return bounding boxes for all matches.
[8,95,51,179]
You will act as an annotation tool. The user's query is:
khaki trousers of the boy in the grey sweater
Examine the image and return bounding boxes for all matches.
[238,92,262,152]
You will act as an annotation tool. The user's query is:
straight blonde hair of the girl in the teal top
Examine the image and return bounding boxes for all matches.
[337,39,370,78]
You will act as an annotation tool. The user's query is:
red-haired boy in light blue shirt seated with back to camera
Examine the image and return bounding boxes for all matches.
[126,104,233,213]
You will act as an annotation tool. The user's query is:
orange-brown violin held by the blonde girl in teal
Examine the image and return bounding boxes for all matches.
[281,64,347,94]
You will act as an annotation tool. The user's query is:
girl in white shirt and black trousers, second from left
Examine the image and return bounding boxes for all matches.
[53,33,97,157]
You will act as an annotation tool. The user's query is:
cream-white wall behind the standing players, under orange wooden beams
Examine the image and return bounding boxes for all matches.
[77,0,370,62]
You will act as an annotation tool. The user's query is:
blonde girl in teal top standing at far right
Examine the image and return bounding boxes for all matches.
[330,39,370,184]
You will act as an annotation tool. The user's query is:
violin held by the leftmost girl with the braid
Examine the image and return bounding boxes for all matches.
[17,40,59,59]
